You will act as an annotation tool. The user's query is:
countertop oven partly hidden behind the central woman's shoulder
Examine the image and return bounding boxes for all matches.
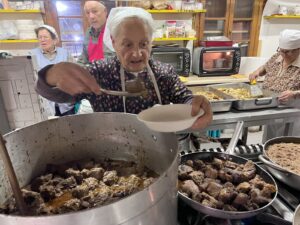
[151,47,191,77]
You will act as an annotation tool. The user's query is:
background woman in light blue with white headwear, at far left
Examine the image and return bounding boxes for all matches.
[31,25,75,116]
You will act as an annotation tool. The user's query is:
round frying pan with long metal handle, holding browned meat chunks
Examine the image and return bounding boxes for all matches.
[178,121,277,219]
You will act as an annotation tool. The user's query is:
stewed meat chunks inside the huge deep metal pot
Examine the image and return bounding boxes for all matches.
[0,159,158,215]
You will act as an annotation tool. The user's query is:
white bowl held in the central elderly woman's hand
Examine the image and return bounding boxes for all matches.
[137,104,204,132]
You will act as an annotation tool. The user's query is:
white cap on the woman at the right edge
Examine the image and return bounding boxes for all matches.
[279,29,300,50]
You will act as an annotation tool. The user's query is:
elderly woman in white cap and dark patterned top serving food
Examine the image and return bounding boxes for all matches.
[36,7,212,128]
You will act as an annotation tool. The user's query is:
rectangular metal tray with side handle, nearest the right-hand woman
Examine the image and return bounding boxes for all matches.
[209,83,279,110]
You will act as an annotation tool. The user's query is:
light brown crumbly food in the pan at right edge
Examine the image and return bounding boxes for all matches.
[266,143,300,176]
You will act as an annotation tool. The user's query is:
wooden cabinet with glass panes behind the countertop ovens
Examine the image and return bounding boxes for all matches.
[201,0,264,56]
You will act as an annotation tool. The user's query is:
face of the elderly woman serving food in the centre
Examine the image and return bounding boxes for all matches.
[112,18,151,72]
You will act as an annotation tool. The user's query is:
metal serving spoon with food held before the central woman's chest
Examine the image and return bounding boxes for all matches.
[100,77,148,97]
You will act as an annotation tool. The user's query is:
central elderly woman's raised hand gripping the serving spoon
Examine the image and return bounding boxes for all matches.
[46,62,100,96]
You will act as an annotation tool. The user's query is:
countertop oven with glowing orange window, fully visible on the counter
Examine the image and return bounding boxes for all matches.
[192,46,241,76]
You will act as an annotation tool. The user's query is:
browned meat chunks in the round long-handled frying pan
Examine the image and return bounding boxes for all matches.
[178,157,276,211]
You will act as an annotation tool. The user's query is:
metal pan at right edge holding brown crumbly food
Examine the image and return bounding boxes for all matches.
[258,137,300,191]
